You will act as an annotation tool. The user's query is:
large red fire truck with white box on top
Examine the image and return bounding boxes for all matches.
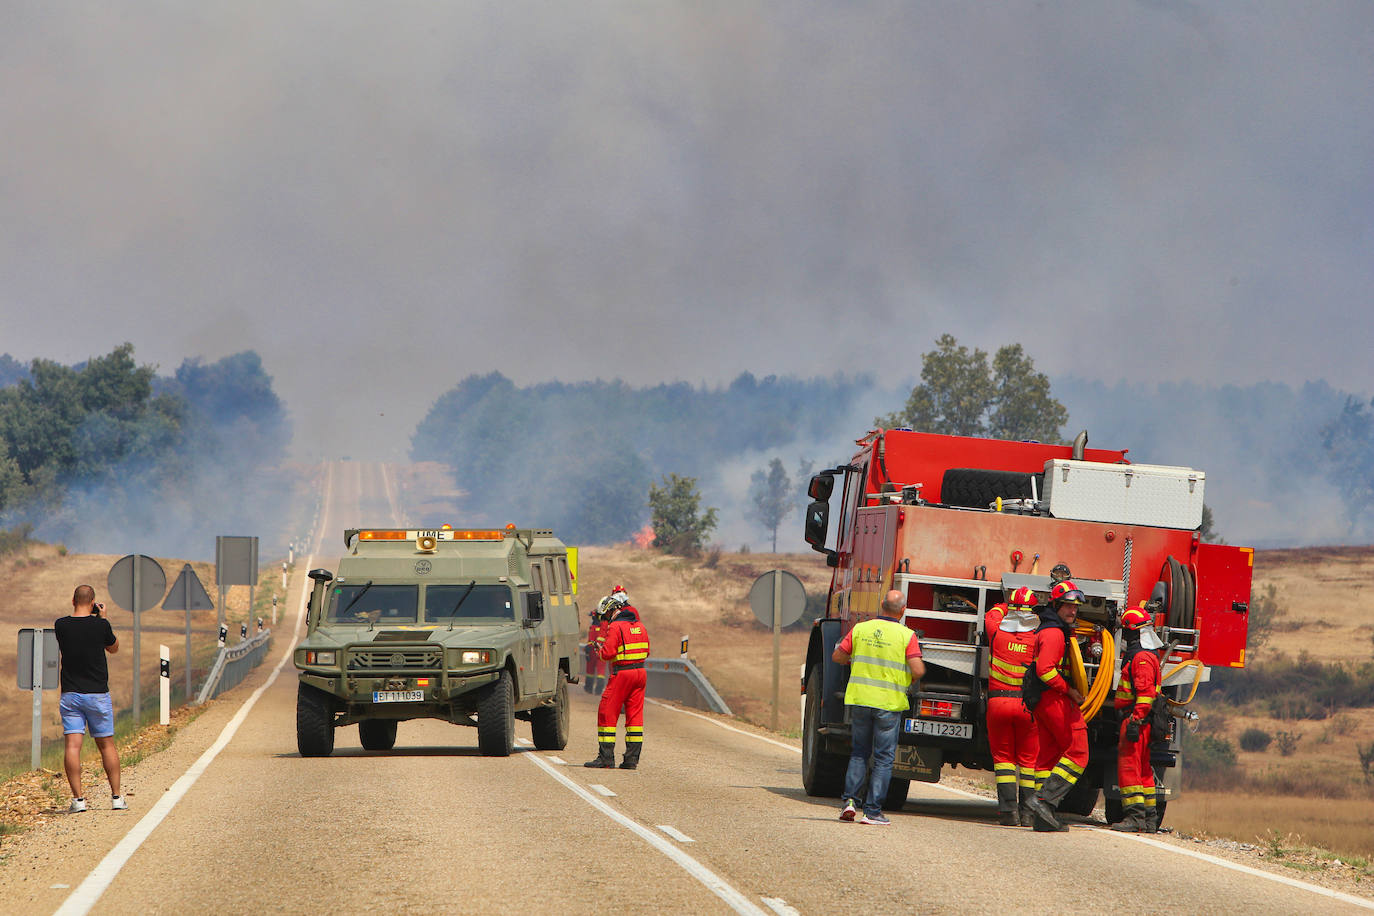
[801,430,1254,821]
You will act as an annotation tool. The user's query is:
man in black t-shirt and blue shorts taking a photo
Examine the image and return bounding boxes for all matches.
[52,585,129,812]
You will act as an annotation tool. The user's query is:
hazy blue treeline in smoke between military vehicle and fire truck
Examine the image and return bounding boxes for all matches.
[411,372,872,544]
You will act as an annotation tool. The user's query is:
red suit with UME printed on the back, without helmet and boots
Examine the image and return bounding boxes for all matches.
[988,629,1040,801]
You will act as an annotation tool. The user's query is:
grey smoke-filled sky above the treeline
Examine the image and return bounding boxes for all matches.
[0,0,1374,457]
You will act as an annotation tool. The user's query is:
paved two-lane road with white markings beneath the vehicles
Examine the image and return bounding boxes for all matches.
[0,463,1356,913]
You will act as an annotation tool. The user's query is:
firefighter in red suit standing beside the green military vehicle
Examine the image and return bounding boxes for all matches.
[585,585,649,769]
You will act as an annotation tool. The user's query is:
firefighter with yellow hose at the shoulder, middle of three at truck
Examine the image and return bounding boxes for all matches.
[1022,580,1088,832]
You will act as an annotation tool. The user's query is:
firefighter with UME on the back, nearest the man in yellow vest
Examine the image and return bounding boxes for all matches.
[988,586,1040,827]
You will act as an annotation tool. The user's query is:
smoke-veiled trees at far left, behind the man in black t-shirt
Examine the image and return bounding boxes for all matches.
[0,343,291,556]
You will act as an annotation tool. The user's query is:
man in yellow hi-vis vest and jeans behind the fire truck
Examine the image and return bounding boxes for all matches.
[831,589,926,827]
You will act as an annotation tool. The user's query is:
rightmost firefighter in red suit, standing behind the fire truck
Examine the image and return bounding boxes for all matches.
[1112,607,1164,834]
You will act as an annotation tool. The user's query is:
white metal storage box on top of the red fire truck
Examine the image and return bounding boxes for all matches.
[1043,459,1206,529]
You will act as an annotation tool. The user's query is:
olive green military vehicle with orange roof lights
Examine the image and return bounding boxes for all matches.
[294,526,585,757]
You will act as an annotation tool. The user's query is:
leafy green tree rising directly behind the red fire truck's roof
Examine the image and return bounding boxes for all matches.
[875,334,1069,442]
